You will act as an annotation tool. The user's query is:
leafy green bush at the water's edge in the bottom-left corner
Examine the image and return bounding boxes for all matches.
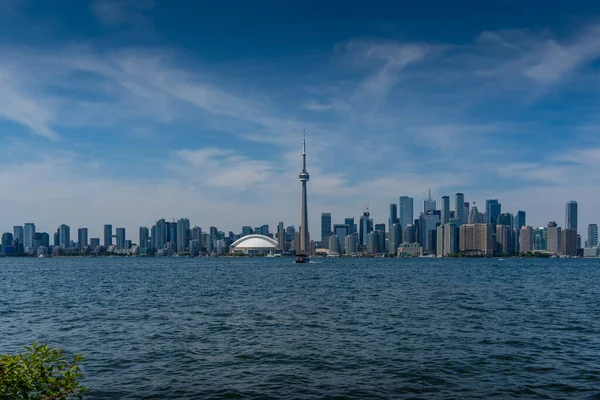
[0,342,85,400]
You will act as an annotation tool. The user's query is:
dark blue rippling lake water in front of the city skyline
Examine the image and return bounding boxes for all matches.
[0,258,600,399]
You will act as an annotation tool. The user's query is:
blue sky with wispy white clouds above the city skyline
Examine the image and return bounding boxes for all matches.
[0,0,600,242]
